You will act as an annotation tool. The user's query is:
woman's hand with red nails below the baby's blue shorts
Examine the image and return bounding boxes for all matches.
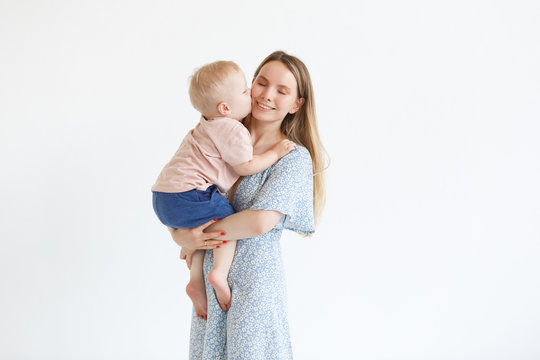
[169,220,221,253]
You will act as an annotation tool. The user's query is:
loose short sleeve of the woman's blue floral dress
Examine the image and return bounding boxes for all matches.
[249,146,315,235]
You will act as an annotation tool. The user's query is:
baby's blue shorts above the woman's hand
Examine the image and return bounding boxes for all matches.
[152,185,234,229]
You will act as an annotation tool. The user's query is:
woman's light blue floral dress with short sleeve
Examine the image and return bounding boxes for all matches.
[189,146,314,360]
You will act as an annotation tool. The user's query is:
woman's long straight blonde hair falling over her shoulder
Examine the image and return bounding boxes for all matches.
[247,51,329,224]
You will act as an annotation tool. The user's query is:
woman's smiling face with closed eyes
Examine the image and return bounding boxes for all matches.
[251,61,303,121]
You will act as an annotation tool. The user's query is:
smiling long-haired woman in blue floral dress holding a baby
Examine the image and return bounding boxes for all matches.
[171,51,326,359]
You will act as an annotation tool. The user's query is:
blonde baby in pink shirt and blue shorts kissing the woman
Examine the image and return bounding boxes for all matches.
[152,61,295,318]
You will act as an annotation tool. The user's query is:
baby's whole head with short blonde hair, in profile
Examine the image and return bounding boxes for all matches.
[189,61,251,120]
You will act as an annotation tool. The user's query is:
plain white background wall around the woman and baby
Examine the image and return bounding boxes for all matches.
[0,0,540,360]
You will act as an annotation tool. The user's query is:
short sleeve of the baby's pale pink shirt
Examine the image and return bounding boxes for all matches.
[214,120,253,166]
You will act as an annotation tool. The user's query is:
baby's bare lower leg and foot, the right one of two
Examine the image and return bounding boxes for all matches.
[208,241,236,311]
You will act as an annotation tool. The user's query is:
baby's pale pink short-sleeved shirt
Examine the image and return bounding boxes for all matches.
[152,116,253,194]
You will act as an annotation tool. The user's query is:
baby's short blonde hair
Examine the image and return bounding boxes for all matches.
[189,61,241,115]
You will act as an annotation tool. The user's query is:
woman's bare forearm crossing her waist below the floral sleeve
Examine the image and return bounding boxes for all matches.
[205,210,283,240]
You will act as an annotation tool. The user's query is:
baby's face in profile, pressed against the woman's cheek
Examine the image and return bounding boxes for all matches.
[220,71,251,120]
